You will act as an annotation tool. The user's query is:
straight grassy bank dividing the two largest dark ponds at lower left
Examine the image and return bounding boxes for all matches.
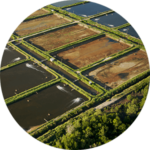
[4,78,60,106]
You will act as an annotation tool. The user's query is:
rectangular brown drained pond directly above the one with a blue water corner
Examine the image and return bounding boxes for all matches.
[29,25,97,51]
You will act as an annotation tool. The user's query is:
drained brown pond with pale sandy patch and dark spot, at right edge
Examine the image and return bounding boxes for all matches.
[89,50,150,88]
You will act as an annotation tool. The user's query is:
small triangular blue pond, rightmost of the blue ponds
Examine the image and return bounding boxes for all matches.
[119,25,141,39]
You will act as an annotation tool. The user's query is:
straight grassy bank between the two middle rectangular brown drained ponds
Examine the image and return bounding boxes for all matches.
[46,33,105,54]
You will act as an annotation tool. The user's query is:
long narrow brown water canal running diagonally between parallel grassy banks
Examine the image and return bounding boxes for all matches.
[15,42,98,95]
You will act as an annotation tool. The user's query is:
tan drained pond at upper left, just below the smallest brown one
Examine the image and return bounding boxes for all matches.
[14,15,69,36]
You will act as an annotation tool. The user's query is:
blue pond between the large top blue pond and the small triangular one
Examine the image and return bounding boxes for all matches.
[91,12,129,27]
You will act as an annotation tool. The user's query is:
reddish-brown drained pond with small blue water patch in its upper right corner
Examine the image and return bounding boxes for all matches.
[57,36,129,68]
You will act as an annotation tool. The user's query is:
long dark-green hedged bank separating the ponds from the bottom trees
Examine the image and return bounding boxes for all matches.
[29,69,150,142]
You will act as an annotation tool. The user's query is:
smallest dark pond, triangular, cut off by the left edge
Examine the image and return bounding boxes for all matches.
[0,45,26,67]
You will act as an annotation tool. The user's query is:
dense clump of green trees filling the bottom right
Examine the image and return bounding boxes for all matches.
[46,85,150,150]
